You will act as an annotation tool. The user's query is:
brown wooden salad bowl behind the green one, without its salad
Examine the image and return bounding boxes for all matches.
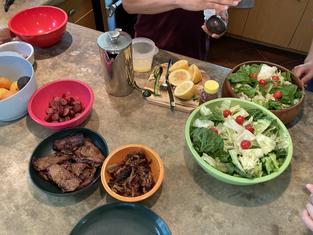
[222,61,304,124]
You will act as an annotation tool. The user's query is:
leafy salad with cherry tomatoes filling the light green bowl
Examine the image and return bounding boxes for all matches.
[190,100,288,178]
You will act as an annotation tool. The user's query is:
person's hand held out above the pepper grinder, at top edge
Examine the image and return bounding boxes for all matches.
[176,0,241,14]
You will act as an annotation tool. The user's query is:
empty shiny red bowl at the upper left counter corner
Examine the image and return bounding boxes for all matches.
[8,6,68,47]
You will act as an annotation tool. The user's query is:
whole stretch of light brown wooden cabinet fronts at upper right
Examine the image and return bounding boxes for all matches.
[228,0,313,53]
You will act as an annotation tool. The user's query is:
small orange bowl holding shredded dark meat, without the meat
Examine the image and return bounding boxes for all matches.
[101,144,164,202]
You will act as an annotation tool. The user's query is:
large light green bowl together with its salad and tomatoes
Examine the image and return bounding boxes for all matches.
[185,98,293,185]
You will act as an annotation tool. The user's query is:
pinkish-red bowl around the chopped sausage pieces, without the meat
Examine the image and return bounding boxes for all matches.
[28,79,94,130]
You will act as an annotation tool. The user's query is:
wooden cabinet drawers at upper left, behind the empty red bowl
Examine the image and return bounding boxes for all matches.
[57,0,96,29]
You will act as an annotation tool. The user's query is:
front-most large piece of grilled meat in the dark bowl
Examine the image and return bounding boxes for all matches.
[47,164,82,192]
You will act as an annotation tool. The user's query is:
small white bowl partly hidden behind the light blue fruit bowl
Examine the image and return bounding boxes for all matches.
[0,41,35,64]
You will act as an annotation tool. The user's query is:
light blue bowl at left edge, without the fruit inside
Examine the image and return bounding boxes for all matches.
[0,56,37,121]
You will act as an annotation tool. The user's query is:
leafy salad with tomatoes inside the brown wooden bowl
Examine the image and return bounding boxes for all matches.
[228,64,303,110]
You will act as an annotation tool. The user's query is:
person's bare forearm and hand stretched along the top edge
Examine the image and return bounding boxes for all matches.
[123,0,240,14]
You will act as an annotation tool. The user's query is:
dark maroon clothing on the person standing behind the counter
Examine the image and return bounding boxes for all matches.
[135,9,208,60]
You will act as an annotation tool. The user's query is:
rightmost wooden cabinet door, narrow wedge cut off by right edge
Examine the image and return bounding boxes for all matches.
[289,0,313,51]
